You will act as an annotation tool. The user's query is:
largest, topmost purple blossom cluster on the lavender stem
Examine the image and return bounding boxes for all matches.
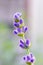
[13,12,27,37]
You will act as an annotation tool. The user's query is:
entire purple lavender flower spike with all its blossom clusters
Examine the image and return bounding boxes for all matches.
[13,12,35,65]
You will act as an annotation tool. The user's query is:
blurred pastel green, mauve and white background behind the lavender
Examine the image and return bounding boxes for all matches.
[0,0,43,65]
